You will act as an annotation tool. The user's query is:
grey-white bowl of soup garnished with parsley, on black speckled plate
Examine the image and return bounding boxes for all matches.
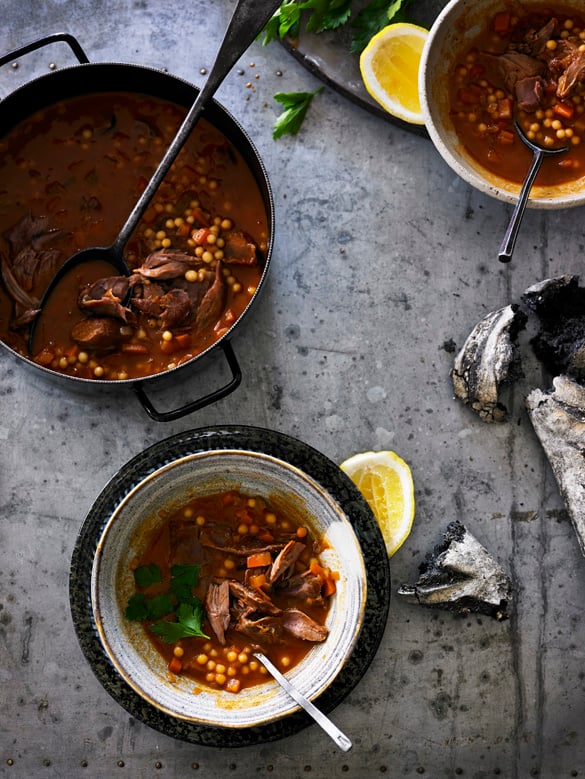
[90,449,367,729]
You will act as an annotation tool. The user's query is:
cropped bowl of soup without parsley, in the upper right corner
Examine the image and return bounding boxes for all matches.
[419,0,585,209]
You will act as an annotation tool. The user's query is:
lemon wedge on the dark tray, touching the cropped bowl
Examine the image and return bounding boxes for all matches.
[360,22,428,124]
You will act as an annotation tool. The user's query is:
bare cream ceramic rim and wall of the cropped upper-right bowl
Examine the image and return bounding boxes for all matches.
[419,0,585,209]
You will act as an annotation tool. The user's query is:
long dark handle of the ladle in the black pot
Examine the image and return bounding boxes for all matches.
[113,0,282,255]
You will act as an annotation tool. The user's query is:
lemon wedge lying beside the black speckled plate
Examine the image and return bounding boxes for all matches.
[340,452,415,557]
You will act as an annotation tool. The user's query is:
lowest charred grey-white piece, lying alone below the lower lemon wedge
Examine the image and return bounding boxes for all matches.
[398,520,512,620]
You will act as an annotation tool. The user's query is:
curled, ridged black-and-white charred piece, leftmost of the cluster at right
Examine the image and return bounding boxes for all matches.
[451,304,527,422]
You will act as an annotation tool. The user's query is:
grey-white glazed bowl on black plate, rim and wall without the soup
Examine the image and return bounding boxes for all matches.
[91,449,366,728]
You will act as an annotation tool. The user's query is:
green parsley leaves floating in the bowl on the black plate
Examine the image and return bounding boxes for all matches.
[124,563,209,644]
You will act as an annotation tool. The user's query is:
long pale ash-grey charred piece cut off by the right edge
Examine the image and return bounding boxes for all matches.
[526,376,585,555]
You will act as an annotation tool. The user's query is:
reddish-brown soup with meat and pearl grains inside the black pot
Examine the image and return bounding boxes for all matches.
[0,92,268,381]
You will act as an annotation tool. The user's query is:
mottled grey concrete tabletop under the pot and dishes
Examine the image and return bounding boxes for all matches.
[0,0,585,779]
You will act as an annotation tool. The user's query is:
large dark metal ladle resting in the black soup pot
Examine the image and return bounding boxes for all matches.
[29,0,282,352]
